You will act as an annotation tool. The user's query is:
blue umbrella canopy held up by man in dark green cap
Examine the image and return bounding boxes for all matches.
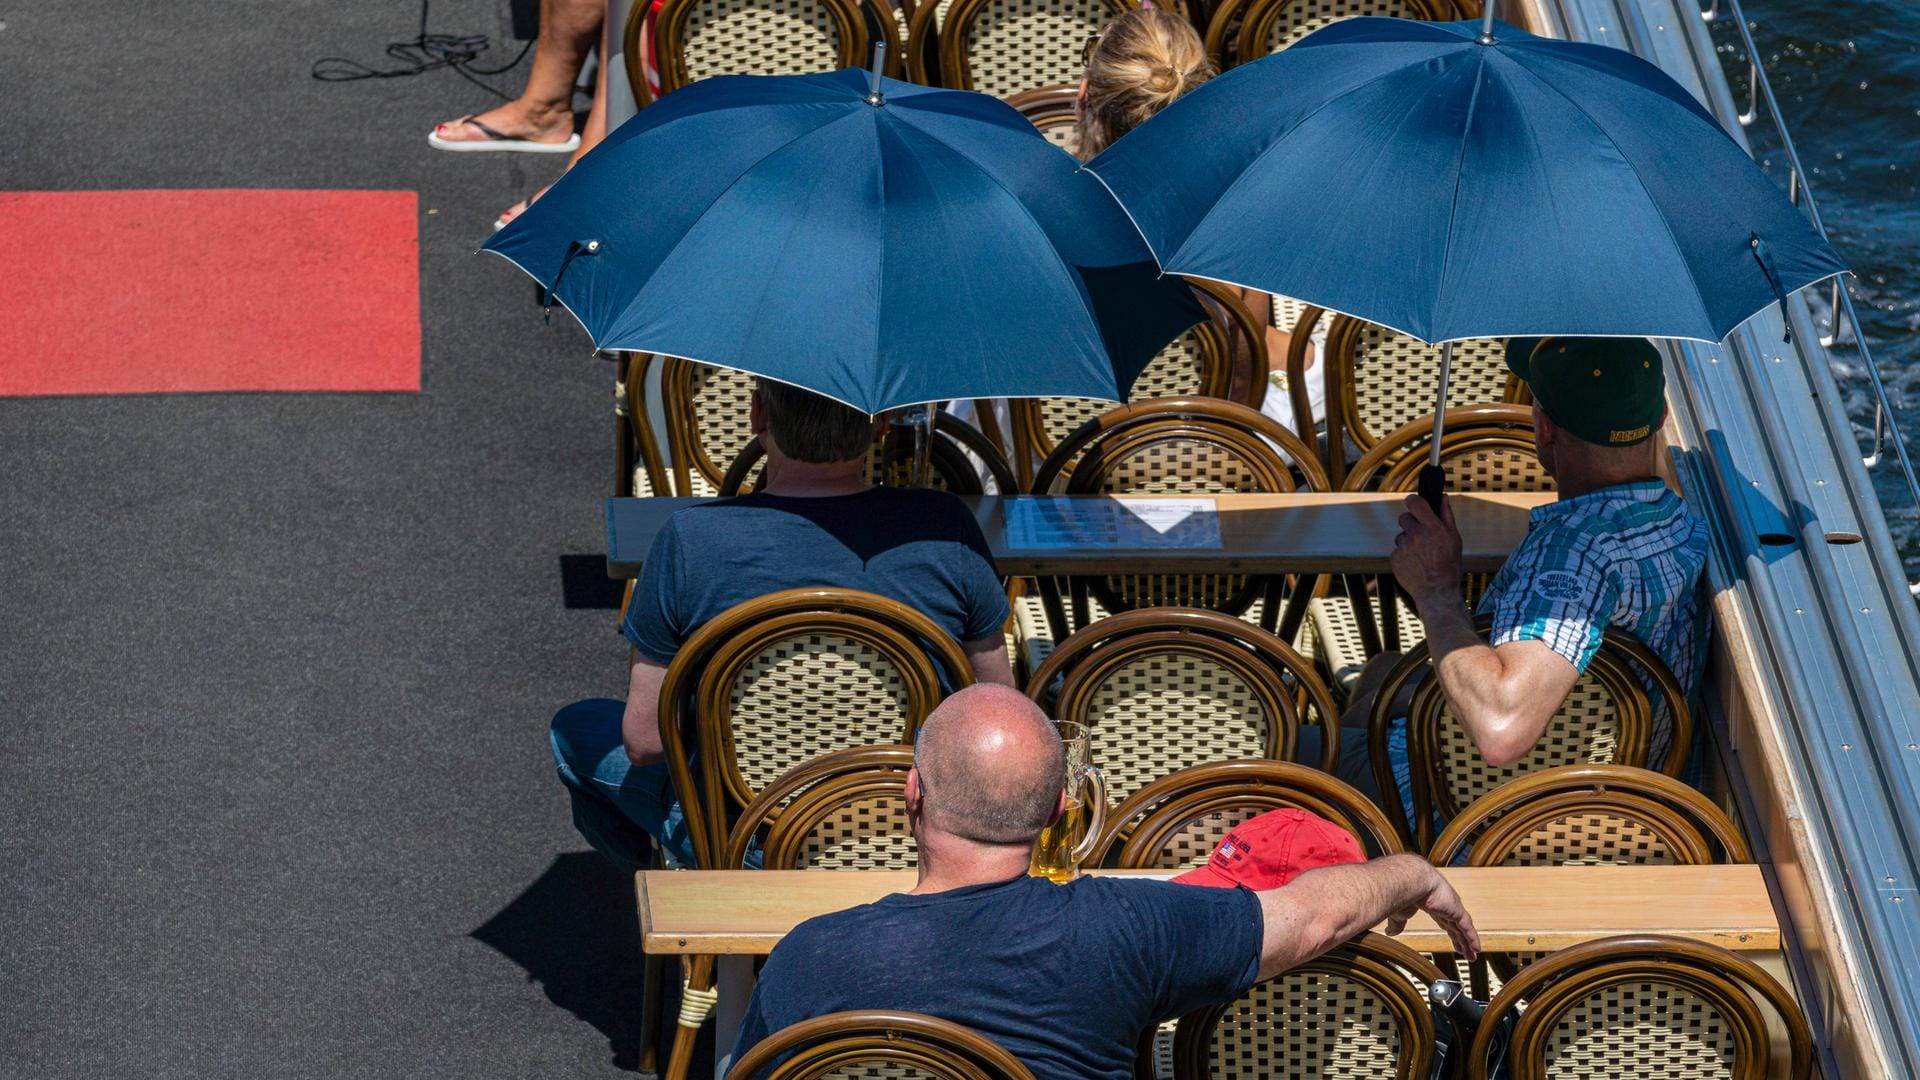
[1087,17,1845,342]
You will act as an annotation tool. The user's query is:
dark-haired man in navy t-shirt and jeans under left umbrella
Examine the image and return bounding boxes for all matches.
[549,380,1014,871]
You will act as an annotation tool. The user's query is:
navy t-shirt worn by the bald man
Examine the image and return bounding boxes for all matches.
[733,874,1261,1080]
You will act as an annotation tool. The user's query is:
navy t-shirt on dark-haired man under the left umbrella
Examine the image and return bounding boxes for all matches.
[620,488,1006,665]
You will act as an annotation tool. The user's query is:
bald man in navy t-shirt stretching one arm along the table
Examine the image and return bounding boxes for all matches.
[733,684,1480,1080]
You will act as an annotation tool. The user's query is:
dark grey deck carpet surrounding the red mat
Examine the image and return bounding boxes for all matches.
[0,0,672,1080]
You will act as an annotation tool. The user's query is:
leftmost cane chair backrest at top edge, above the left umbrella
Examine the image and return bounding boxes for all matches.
[624,0,900,106]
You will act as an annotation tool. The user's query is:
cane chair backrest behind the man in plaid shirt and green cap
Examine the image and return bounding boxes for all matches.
[1369,615,1693,851]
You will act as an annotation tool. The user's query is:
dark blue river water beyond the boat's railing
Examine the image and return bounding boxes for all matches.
[1715,0,1920,577]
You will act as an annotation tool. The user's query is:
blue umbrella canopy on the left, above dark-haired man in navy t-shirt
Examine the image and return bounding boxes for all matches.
[486,69,1204,413]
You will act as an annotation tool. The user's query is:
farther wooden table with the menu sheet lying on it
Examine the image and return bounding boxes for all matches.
[607,492,1553,578]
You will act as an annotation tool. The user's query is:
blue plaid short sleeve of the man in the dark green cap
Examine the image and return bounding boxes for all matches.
[1480,528,1620,673]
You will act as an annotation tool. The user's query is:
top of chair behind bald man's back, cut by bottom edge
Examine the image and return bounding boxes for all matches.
[728,1011,1033,1080]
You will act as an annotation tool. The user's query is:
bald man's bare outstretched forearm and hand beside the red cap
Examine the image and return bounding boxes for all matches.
[1260,855,1480,980]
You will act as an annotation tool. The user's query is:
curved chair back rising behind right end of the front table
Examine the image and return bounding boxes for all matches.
[1427,765,1753,867]
